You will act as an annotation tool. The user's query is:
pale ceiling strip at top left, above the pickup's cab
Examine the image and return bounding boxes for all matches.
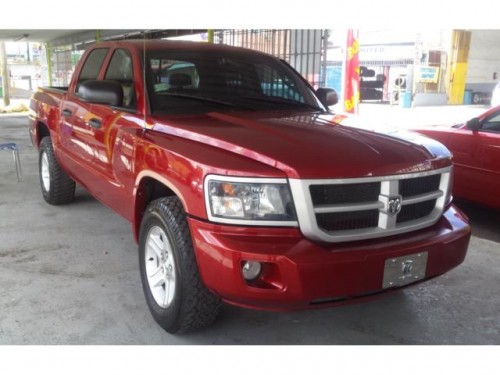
[0,29,206,47]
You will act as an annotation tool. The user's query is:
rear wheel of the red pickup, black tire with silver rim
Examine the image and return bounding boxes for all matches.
[38,137,75,205]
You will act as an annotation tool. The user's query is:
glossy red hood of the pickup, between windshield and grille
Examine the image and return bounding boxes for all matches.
[153,112,451,179]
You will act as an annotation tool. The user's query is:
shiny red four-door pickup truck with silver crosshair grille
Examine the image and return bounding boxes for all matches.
[30,40,470,333]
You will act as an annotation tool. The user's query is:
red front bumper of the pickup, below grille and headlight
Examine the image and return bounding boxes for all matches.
[189,206,470,310]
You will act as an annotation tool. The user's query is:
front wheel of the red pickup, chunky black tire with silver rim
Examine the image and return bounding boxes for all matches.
[139,197,221,333]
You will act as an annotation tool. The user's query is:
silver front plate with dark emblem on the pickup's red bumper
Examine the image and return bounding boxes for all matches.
[382,252,427,289]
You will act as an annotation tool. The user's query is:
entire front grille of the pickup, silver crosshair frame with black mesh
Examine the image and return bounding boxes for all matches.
[290,167,451,242]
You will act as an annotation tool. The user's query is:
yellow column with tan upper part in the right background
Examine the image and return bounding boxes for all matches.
[446,30,471,104]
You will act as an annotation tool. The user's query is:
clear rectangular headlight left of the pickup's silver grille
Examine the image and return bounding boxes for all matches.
[205,175,297,226]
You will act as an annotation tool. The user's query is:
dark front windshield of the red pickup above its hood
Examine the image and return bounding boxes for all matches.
[146,50,326,114]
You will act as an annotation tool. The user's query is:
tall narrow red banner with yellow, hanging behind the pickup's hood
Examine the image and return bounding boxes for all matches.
[344,29,360,113]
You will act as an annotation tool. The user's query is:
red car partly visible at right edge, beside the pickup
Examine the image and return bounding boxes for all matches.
[416,106,500,209]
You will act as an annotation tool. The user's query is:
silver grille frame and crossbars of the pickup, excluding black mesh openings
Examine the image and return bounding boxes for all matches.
[289,166,452,242]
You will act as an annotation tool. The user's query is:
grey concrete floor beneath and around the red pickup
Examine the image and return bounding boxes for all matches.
[0,104,500,345]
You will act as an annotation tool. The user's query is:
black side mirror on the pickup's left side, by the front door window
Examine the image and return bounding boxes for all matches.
[78,80,123,107]
